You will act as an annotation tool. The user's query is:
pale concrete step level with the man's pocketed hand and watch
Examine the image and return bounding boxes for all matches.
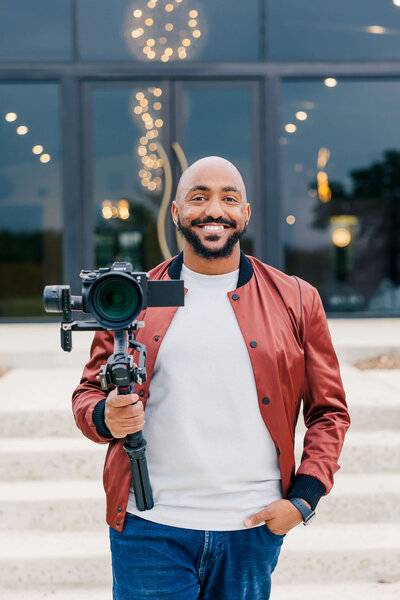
[0,473,400,531]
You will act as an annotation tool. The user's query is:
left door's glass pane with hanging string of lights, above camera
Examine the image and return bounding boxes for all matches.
[94,84,165,271]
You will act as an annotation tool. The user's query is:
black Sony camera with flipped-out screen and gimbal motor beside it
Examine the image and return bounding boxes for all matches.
[43,262,184,351]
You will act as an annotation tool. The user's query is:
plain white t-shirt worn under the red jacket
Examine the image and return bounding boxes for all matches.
[128,265,282,531]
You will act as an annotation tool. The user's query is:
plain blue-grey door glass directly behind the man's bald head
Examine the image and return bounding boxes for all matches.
[182,84,257,254]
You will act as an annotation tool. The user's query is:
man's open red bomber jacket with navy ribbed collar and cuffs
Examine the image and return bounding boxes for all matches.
[72,253,350,531]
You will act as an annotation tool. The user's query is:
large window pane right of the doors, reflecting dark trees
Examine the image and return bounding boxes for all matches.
[281,80,400,311]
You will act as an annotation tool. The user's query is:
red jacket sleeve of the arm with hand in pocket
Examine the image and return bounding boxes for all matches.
[289,286,350,508]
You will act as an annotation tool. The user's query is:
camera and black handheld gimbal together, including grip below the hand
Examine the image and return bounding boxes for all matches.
[44,263,184,511]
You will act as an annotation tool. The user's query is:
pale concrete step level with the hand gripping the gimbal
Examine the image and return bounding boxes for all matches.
[0,364,400,438]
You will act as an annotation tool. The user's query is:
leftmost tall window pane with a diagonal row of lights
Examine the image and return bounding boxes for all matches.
[0,83,62,317]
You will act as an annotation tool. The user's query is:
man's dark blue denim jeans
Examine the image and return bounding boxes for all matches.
[110,514,284,600]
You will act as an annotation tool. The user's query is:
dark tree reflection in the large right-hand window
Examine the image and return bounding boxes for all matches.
[312,150,400,309]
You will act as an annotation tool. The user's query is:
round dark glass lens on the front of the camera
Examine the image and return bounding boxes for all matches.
[89,273,143,329]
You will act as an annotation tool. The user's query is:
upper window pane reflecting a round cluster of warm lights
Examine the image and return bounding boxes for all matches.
[78,0,261,62]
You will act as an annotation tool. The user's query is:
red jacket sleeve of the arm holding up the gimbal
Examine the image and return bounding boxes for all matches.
[72,331,114,444]
